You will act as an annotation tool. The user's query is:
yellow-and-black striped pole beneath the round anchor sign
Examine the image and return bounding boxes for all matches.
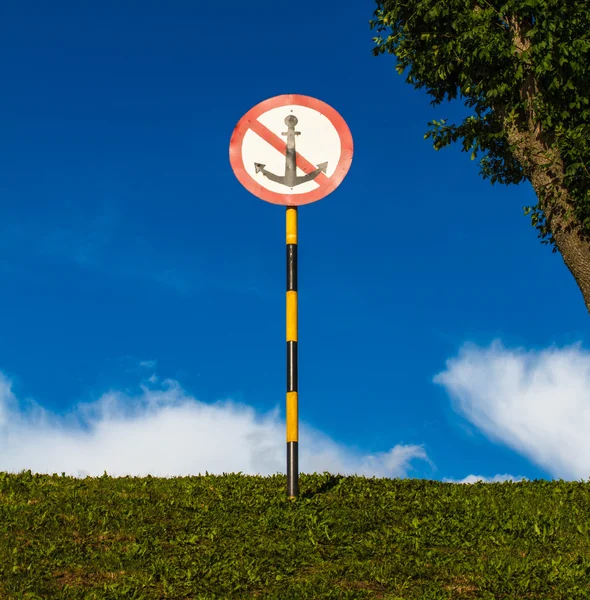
[287,206,299,499]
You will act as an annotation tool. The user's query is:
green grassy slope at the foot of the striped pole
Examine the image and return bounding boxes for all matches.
[0,471,590,600]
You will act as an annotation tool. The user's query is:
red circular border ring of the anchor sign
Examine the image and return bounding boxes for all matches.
[229,94,354,206]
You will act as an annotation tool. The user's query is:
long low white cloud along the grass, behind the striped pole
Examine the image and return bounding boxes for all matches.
[0,373,430,477]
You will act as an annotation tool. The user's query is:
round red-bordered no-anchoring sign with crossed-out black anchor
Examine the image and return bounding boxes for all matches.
[229,94,353,206]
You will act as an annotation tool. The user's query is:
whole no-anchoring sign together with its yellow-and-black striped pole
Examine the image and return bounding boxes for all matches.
[229,94,353,499]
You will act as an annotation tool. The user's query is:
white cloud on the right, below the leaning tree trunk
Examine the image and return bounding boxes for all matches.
[434,340,590,480]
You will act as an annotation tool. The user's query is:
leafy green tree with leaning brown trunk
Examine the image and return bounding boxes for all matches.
[370,0,590,312]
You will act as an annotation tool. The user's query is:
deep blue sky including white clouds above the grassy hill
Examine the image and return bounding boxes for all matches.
[0,0,590,481]
